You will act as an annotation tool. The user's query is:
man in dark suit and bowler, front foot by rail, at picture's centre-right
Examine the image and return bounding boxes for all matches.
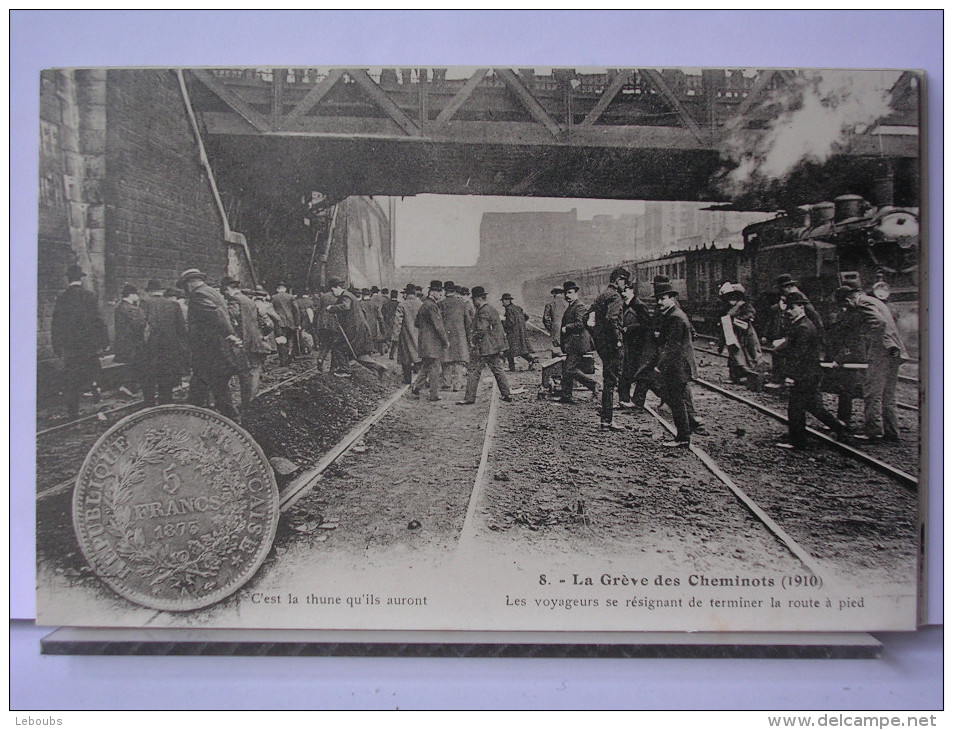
[655,285,698,447]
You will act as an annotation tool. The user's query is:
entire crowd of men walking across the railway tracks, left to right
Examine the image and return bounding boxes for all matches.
[52,265,907,449]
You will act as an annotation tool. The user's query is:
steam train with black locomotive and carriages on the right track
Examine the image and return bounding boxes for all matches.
[527,195,920,357]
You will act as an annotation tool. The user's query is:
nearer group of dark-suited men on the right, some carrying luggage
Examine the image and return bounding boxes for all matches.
[543,268,907,449]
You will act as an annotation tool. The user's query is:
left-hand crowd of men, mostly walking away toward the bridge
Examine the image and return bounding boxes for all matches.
[52,265,537,422]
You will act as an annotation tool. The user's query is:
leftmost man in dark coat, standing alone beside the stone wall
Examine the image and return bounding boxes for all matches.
[50,264,109,418]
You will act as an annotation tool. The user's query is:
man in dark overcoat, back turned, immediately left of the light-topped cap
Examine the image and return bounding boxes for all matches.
[139,279,188,407]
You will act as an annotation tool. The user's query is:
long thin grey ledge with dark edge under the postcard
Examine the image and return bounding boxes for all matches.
[41,627,883,659]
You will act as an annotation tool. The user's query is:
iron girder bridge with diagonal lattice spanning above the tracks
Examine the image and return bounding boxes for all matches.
[190,68,920,200]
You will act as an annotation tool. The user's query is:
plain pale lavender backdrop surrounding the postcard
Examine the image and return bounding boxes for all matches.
[10,11,943,710]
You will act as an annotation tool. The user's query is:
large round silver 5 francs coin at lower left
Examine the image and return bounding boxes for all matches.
[73,405,278,611]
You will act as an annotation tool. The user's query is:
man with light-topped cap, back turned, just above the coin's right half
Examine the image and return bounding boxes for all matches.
[177,269,241,420]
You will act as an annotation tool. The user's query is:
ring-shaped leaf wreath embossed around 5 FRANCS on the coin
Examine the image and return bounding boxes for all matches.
[103,426,247,594]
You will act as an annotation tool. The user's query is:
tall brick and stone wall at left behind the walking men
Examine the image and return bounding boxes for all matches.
[37,69,234,392]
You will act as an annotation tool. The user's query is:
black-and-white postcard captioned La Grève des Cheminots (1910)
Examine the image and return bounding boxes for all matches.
[36,65,929,632]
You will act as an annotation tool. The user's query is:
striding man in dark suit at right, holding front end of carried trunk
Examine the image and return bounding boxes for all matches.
[776,292,847,449]
